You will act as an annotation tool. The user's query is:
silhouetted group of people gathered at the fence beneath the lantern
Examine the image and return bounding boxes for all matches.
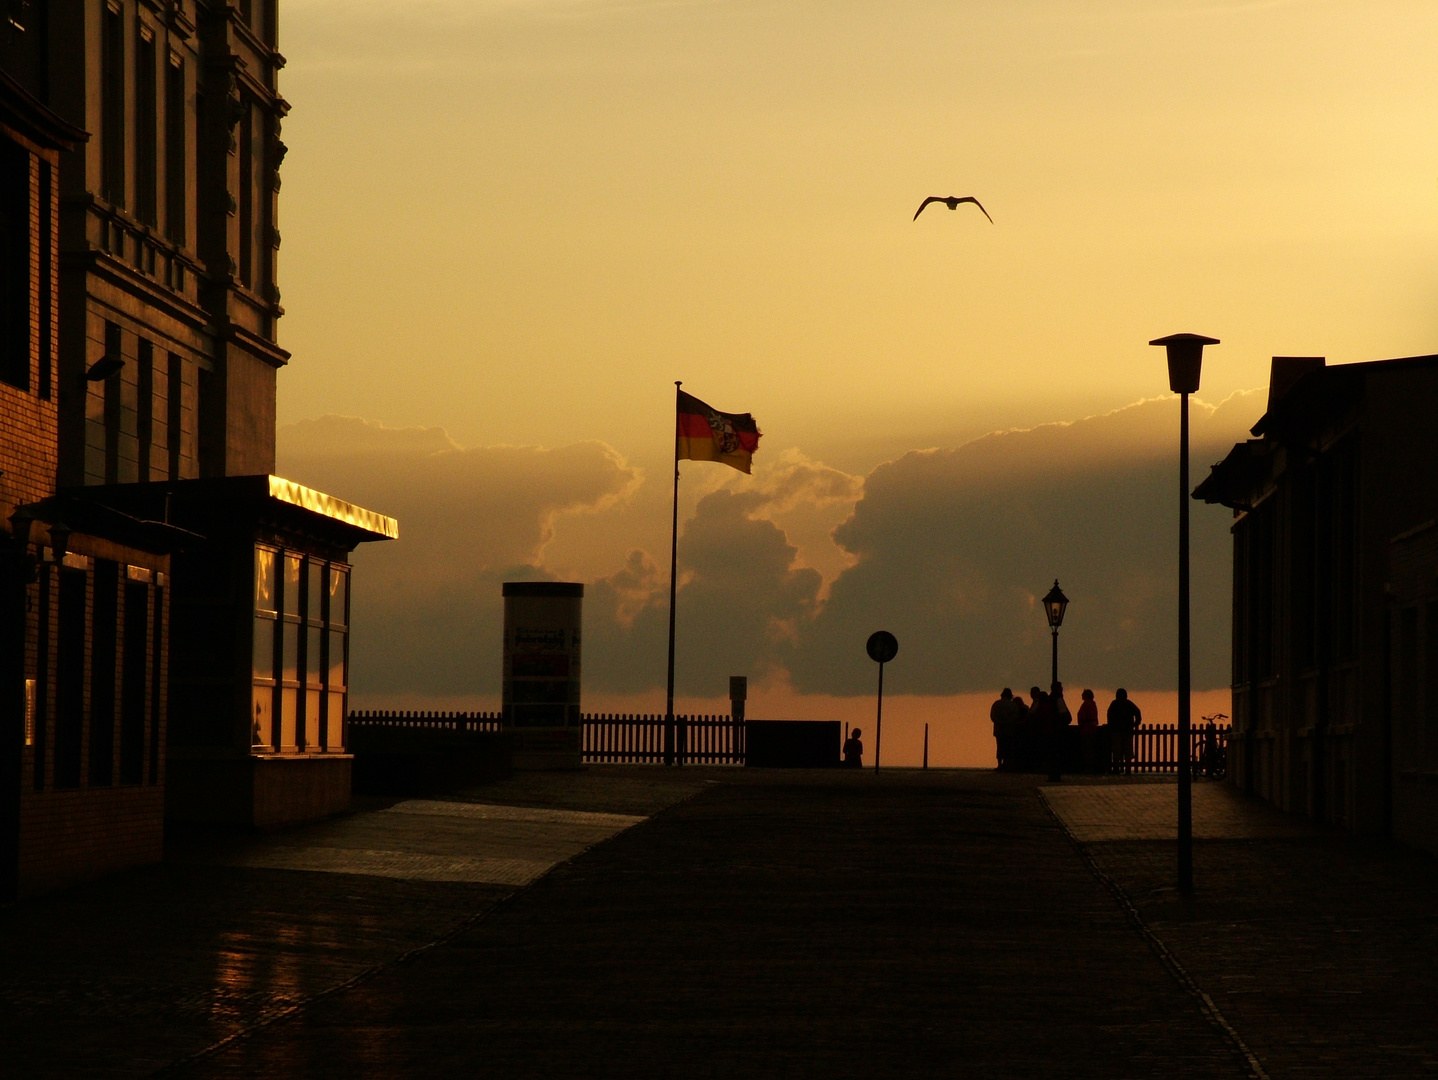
[989,683,1143,779]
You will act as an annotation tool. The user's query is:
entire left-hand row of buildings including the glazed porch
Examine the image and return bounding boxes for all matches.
[0,0,397,894]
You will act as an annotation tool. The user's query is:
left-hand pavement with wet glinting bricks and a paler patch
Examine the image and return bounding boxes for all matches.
[0,769,703,1080]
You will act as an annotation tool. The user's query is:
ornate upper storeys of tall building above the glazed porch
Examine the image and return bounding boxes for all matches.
[47,0,289,486]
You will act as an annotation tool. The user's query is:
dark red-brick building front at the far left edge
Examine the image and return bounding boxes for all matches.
[0,6,183,899]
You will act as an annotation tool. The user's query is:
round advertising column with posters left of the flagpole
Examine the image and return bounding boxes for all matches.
[503,581,584,769]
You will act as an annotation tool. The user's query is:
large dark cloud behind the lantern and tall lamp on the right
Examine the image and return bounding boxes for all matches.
[791,394,1263,693]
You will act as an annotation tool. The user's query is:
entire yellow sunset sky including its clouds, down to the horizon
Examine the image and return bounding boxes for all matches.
[270,0,1438,756]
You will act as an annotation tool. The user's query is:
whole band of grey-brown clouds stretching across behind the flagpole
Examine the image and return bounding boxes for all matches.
[279,391,1263,696]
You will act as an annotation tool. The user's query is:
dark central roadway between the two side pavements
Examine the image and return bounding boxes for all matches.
[175,771,1244,1080]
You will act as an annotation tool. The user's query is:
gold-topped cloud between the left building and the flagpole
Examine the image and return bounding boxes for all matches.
[278,416,640,693]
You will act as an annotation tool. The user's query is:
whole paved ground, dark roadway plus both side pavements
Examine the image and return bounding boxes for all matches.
[0,768,1438,1080]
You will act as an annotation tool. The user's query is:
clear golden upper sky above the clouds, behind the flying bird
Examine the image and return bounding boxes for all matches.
[280,0,1438,467]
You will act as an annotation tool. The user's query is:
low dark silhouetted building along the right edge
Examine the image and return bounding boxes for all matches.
[1194,357,1438,850]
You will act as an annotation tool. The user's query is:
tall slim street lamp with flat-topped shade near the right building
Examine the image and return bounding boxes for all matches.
[1149,334,1218,893]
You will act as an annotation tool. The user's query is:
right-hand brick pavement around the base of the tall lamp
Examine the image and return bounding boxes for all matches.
[1043,782,1438,1080]
